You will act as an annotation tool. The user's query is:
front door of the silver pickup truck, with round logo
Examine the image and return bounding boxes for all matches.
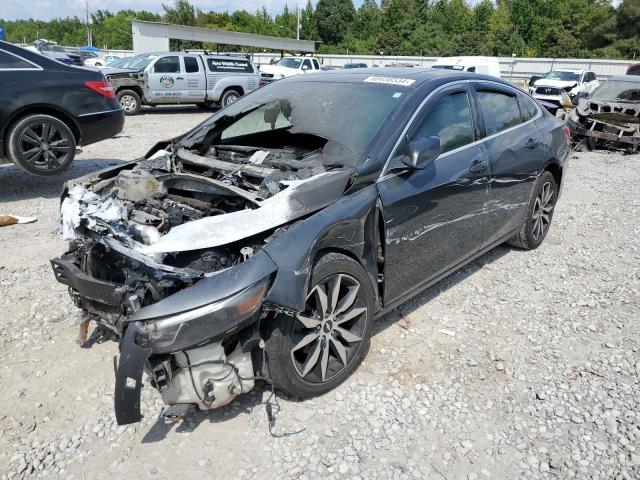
[149,55,187,103]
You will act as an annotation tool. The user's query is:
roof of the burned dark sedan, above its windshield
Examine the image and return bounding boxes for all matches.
[278,68,510,88]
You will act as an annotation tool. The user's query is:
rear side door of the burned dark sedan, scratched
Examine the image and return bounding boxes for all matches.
[475,82,545,246]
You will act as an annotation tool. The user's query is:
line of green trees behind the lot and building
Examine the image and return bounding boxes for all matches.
[0,0,640,59]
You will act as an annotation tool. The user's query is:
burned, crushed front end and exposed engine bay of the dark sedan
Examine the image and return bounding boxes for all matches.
[51,108,354,424]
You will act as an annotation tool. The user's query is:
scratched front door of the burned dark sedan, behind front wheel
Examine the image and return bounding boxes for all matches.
[378,84,489,303]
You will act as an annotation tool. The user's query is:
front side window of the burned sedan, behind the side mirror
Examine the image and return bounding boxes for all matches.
[414,92,474,153]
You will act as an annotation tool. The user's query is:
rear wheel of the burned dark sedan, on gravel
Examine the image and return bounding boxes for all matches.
[507,171,558,250]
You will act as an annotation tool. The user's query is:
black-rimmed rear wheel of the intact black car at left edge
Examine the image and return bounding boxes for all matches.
[7,114,76,176]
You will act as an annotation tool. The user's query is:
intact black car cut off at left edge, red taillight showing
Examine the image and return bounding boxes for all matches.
[0,42,124,175]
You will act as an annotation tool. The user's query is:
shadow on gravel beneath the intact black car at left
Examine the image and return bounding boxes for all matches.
[0,158,124,203]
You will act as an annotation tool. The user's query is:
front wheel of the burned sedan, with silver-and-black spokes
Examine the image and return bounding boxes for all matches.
[265,253,375,399]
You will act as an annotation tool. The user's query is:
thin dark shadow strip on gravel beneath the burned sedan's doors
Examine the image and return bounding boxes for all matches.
[371,245,510,337]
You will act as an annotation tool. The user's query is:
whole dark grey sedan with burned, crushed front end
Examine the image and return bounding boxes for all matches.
[52,69,570,423]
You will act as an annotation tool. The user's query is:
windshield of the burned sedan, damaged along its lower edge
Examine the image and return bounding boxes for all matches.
[182,81,410,166]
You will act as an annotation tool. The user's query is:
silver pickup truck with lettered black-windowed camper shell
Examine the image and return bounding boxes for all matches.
[102,52,260,115]
